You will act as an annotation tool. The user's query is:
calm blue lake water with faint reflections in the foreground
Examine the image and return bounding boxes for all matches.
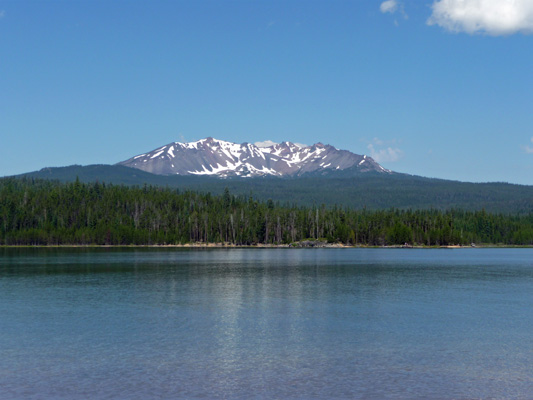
[0,249,533,399]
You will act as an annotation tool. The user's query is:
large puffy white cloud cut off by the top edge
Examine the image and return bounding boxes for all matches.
[427,0,533,36]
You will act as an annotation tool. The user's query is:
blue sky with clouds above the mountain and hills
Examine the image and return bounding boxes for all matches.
[0,0,533,185]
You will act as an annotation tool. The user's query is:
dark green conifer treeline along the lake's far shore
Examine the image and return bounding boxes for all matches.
[0,178,533,246]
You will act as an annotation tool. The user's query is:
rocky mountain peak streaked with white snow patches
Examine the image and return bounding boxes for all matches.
[118,137,390,177]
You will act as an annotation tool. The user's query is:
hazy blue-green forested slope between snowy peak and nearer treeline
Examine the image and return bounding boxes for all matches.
[12,165,533,214]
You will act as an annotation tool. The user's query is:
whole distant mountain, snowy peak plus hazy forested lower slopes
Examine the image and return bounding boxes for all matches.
[4,138,533,214]
